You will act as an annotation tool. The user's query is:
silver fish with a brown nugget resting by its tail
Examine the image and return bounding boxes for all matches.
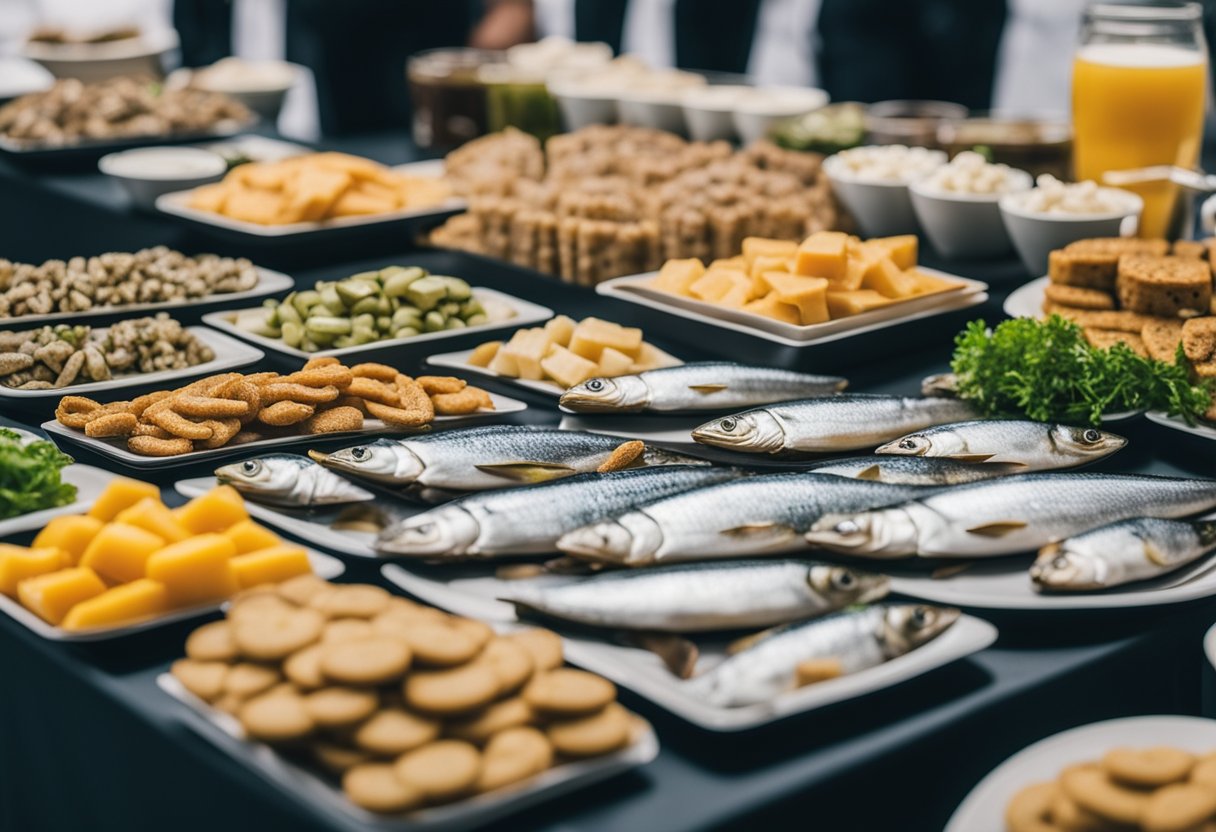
[309,425,708,491]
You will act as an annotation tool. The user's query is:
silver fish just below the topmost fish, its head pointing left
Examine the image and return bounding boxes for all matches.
[692,393,978,454]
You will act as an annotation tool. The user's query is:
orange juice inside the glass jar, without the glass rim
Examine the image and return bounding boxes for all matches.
[1073,43,1207,237]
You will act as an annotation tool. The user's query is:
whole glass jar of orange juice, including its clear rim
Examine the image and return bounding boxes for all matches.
[1073,2,1207,237]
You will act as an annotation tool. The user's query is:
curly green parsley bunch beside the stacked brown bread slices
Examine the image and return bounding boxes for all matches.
[951,315,1211,425]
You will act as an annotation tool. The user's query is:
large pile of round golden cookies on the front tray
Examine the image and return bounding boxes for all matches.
[173,575,636,813]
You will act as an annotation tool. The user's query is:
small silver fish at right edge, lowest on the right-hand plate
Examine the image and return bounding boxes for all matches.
[1030,517,1216,592]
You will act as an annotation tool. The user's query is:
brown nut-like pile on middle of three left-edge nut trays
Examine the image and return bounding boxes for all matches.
[0,246,258,317]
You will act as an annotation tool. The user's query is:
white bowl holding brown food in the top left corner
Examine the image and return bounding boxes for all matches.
[21,29,178,81]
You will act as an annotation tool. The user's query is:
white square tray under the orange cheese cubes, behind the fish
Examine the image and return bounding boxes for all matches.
[596,266,987,347]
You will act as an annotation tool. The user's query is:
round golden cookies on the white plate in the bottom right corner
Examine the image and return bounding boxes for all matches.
[1004,747,1216,832]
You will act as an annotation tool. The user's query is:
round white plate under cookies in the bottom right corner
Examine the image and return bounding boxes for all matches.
[945,715,1216,832]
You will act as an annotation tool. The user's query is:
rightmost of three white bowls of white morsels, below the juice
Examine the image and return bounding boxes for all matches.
[1000,187,1144,275]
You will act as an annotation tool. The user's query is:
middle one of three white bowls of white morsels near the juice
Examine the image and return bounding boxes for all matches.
[908,170,1035,260]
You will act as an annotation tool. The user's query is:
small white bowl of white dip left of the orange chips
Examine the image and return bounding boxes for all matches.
[97,147,227,210]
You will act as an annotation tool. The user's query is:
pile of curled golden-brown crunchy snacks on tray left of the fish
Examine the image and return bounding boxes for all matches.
[55,356,494,456]
